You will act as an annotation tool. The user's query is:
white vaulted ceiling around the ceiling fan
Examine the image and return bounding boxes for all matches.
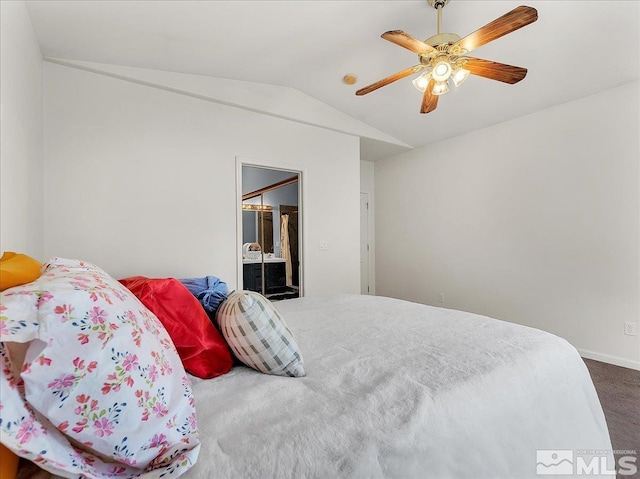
[27,0,640,153]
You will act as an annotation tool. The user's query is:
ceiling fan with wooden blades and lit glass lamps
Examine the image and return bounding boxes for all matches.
[356,0,538,113]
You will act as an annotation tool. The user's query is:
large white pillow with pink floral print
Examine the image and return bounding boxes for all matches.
[0,258,199,478]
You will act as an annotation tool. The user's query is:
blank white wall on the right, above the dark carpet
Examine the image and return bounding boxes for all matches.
[375,82,640,369]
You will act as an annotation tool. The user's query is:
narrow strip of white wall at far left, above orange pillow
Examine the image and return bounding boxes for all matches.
[0,1,44,260]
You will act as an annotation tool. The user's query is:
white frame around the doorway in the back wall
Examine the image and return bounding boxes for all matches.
[236,156,308,297]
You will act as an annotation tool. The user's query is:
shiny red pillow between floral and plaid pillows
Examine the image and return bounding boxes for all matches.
[120,276,233,379]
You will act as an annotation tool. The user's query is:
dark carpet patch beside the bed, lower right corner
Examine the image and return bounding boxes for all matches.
[584,359,640,479]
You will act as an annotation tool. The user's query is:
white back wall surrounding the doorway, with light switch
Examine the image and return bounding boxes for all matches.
[45,63,360,295]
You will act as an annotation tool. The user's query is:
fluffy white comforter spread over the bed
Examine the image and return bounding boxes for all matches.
[184,296,611,479]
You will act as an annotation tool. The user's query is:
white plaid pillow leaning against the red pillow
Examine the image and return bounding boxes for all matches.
[216,291,305,377]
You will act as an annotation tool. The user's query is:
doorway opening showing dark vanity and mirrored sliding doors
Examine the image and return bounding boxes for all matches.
[239,164,302,301]
